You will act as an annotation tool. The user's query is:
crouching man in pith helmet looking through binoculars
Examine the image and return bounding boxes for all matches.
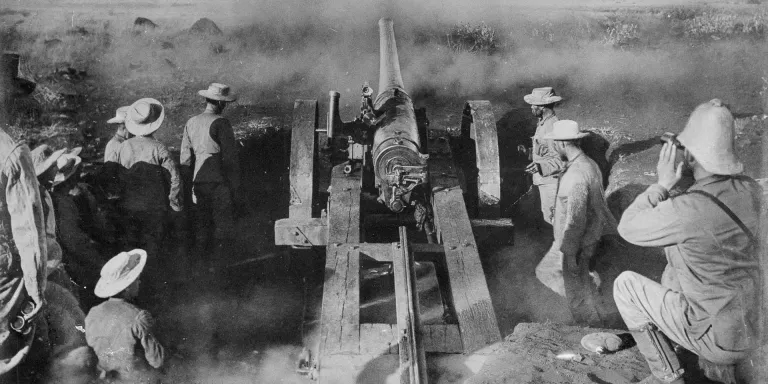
[614,99,762,384]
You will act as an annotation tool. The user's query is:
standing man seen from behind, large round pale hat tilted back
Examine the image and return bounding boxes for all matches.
[118,98,183,272]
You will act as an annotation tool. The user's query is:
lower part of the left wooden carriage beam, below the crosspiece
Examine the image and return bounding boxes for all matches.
[320,244,360,357]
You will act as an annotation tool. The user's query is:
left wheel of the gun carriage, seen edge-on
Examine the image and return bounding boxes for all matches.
[288,100,317,219]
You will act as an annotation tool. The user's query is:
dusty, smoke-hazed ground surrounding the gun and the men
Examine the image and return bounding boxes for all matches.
[0,0,768,384]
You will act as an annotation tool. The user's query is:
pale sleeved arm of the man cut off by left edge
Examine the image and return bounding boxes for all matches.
[4,146,47,317]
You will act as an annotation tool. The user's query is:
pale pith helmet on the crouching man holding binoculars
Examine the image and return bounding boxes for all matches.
[677,99,744,175]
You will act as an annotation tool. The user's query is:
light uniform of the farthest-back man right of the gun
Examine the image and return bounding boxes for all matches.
[531,115,565,224]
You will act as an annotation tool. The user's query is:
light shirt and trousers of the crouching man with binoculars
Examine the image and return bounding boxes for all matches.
[614,175,762,364]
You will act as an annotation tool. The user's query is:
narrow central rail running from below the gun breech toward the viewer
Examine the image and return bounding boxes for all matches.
[392,227,427,384]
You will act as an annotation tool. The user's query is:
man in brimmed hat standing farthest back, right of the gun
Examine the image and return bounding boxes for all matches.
[518,87,564,224]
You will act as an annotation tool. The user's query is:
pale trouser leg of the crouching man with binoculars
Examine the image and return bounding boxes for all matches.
[613,271,747,364]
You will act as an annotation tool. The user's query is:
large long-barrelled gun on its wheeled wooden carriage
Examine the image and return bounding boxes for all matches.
[275,18,511,383]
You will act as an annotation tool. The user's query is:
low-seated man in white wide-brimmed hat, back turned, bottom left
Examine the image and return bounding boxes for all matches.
[85,249,165,383]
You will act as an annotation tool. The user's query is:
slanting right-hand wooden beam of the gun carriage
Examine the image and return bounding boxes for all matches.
[433,189,501,353]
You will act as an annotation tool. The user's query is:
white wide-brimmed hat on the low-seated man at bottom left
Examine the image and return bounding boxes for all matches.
[93,249,147,298]
